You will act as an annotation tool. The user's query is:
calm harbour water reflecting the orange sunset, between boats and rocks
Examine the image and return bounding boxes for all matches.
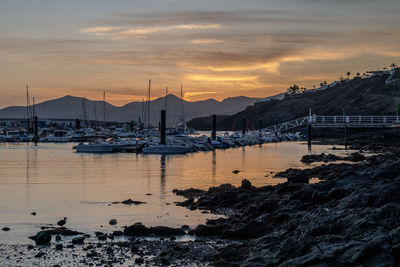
[0,142,346,244]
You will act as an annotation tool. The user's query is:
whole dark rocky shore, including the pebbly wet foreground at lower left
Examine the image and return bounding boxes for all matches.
[0,143,400,266]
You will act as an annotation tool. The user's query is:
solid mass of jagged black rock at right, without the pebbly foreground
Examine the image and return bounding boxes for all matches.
[176,148,400,266]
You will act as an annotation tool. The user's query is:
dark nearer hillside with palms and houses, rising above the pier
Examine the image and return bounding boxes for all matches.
[188,75,400,130]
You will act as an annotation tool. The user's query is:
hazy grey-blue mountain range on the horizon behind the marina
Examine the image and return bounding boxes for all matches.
[0,94,257,126]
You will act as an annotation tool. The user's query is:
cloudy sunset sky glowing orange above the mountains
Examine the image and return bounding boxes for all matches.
[0,0,400,108]
